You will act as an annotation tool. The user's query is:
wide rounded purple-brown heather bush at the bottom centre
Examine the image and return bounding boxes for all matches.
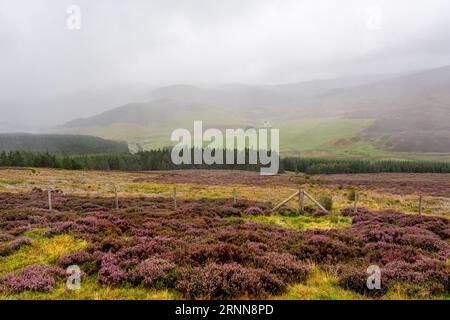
[176,263,286,299]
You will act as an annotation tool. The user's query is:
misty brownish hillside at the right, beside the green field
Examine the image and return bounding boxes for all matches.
[313,67,450,152]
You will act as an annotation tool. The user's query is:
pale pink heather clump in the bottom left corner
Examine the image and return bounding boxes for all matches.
[0,265,65,293]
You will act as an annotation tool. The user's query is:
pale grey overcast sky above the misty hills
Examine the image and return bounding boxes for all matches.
[0,0,450,126]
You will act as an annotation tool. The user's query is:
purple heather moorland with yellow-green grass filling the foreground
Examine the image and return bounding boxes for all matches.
[0,169,450,299]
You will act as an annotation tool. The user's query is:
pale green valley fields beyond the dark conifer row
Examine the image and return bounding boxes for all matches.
[63,116,450,161]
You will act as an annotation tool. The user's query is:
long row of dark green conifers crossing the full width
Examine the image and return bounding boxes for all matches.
[0,149,450,174]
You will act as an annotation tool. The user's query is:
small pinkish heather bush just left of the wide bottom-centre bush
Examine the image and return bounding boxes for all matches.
[131,257,175,288]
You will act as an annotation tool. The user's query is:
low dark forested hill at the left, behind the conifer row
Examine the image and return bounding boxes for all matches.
[0,133,128,154]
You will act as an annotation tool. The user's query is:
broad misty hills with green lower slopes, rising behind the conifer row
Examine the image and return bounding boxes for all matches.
[59,66,450,156]
